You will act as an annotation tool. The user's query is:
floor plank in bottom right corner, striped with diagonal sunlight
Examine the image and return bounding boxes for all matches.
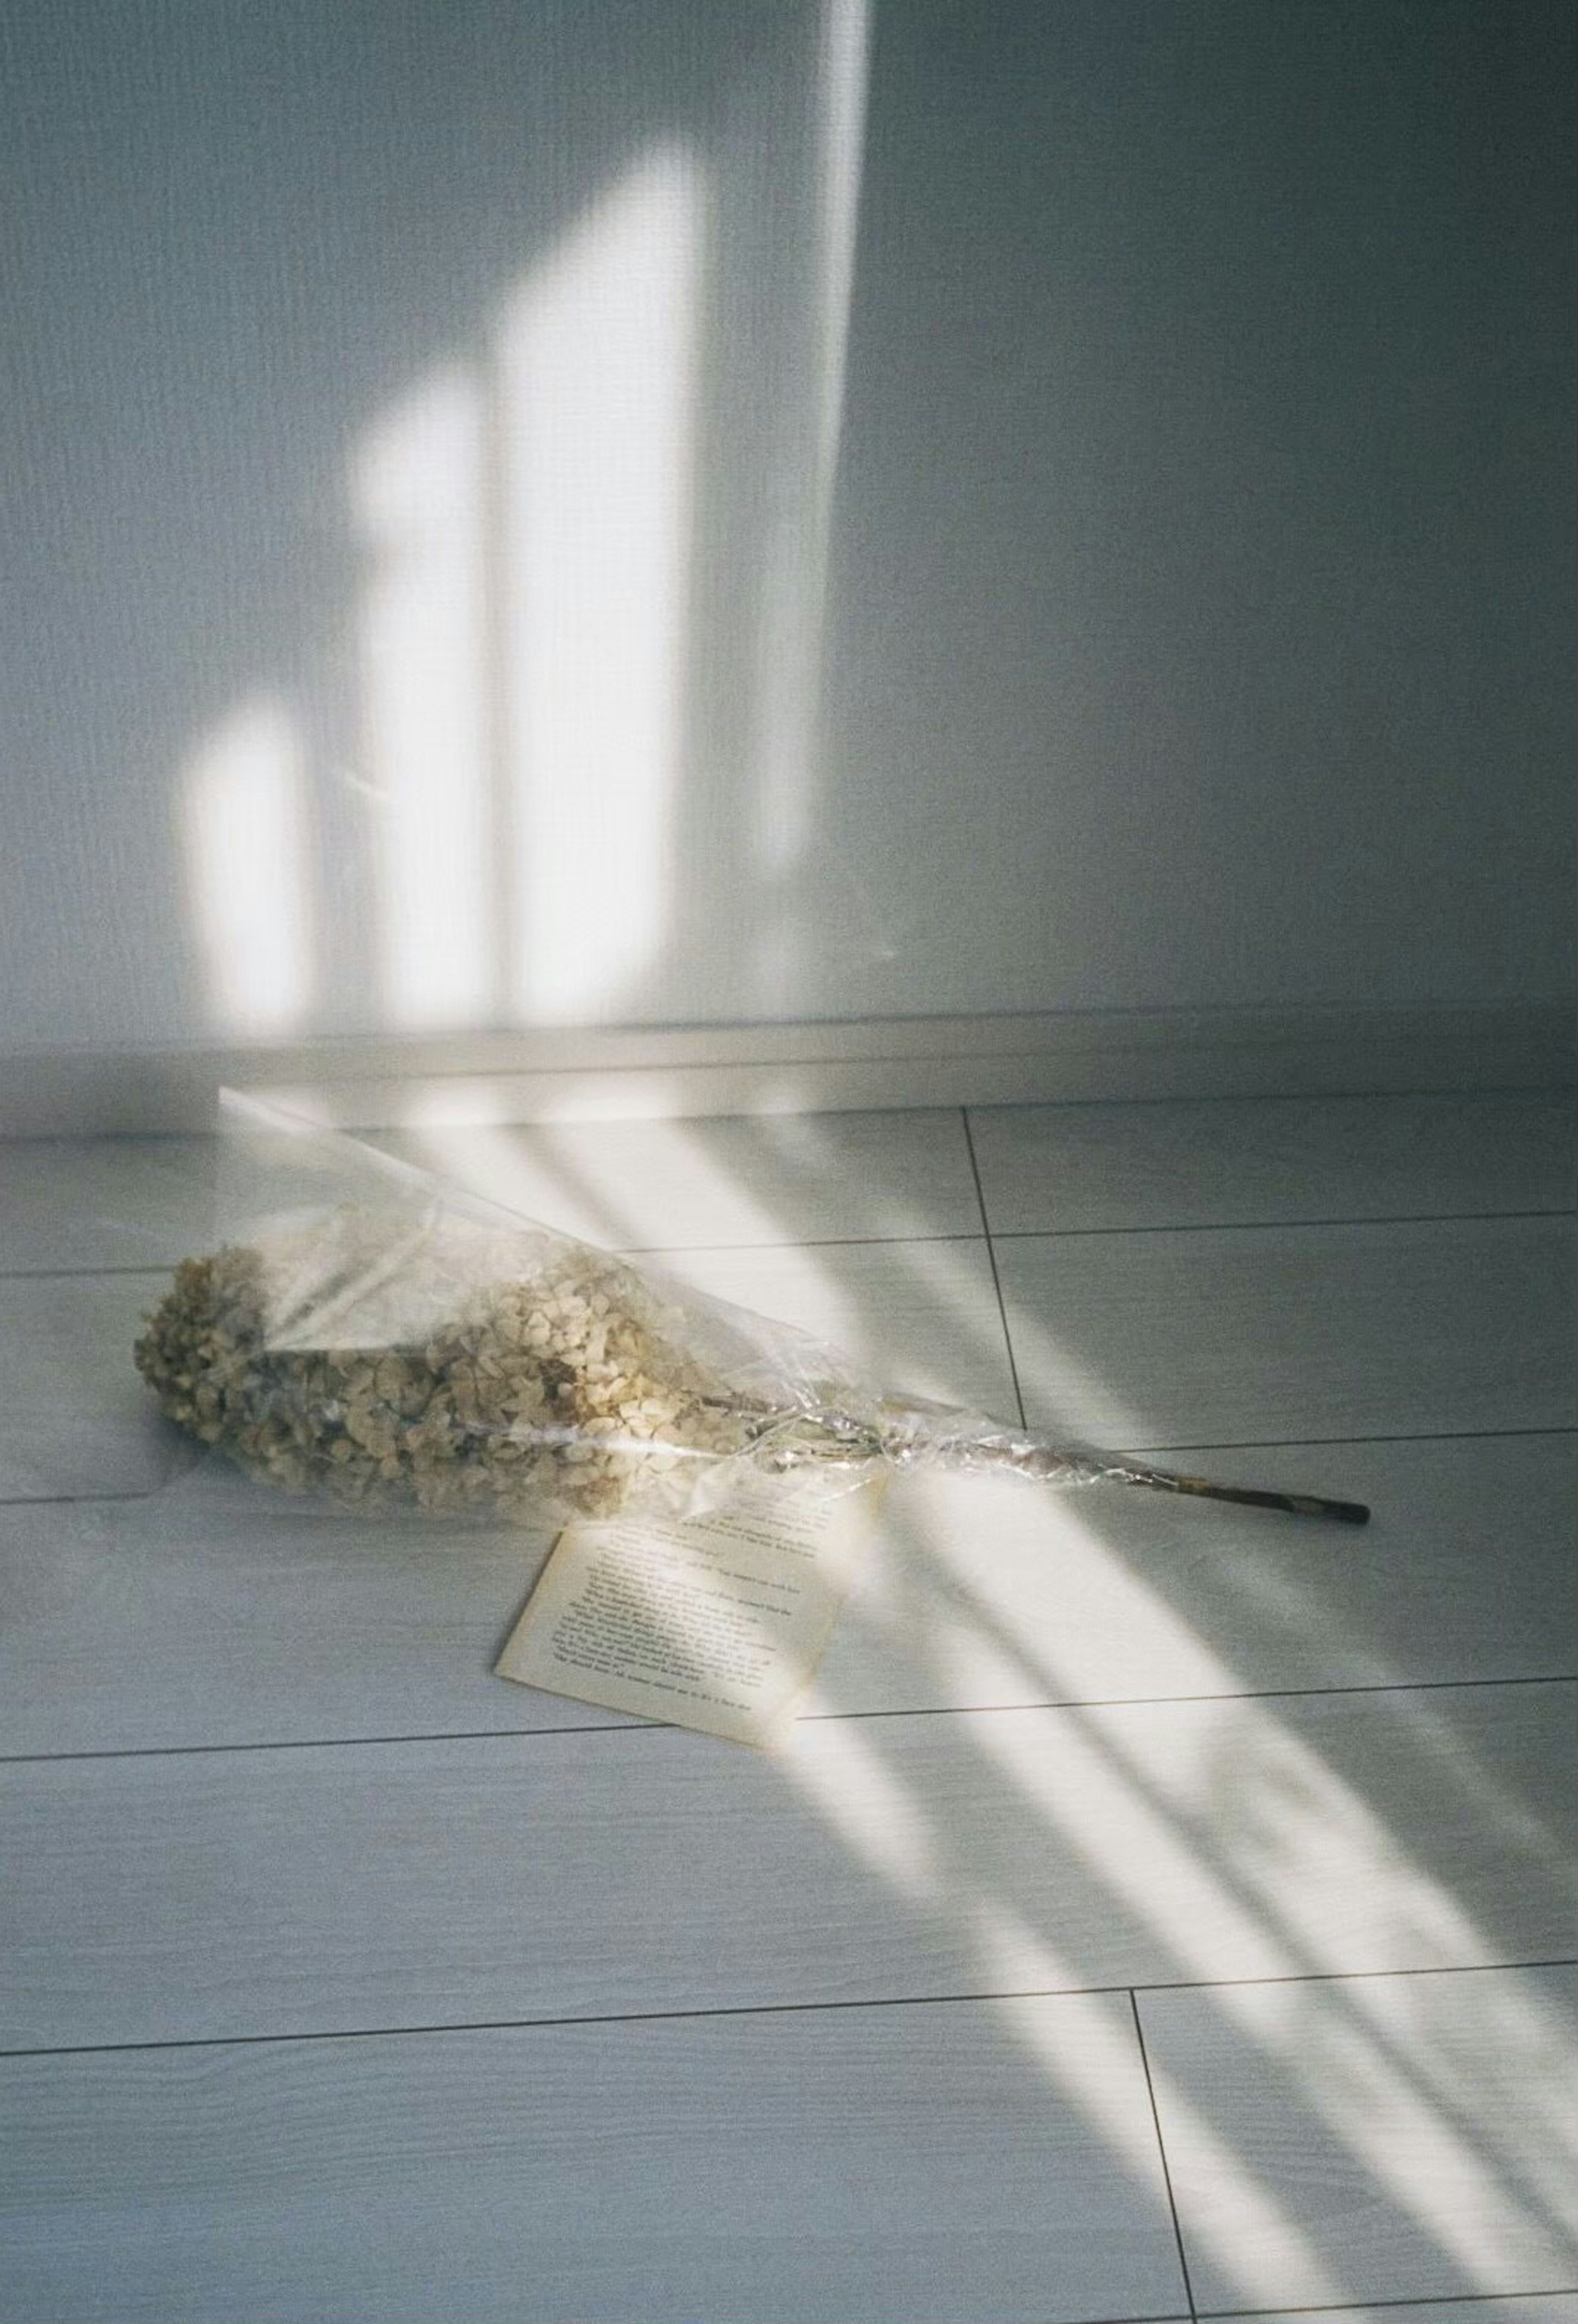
[1139,1969,1578,2315]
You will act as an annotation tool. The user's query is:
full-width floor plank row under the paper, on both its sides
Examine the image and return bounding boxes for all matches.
[0,1436,1573,1752]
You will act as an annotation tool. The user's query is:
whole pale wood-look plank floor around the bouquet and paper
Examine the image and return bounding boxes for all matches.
[0,1092,1578,2324]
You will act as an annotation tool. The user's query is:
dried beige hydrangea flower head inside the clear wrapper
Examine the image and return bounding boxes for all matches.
[135,1206,748,1515]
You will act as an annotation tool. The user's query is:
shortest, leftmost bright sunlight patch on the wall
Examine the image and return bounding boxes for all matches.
[181,697,314,1039]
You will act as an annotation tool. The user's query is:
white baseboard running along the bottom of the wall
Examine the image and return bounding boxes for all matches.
[0,1004,1573,1137]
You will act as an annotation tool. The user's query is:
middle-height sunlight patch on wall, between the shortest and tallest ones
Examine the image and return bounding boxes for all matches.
[353,372,495,1030]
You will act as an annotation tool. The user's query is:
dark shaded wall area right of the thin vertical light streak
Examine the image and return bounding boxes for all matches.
[827,0,1573,1009]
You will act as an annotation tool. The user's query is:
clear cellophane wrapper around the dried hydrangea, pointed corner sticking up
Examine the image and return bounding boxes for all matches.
[137,1092,1134,1524]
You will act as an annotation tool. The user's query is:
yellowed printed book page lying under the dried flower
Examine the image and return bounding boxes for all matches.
[495,1469,886,1745]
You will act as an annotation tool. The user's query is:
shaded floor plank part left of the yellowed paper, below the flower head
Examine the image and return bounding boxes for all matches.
[0,1459,623,1755]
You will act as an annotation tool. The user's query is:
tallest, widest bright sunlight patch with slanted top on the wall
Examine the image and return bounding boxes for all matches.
[500,146,706,1023]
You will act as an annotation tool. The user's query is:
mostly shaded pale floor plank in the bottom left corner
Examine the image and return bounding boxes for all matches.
[0,1997,1188,2324]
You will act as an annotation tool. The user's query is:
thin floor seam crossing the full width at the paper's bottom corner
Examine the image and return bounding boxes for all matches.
[0,1671,1578,1766]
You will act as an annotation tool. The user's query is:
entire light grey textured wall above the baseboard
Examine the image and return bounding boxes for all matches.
[0,0,1573,1051]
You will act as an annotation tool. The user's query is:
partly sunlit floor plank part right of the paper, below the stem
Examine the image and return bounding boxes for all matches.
[820,1436,1578,1711]
